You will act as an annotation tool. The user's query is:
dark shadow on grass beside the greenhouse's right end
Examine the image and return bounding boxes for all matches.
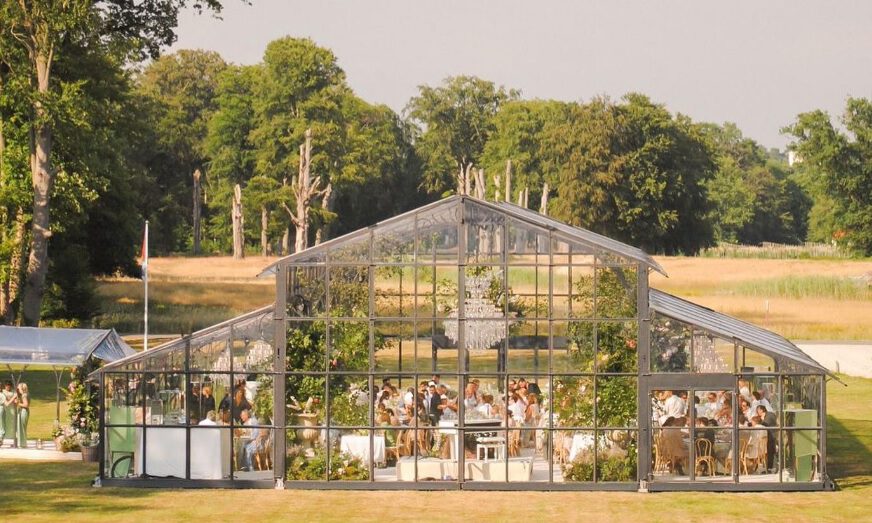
[827,416,872,489]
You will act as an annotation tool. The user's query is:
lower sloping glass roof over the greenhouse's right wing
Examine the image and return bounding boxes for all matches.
[648,289,832,375]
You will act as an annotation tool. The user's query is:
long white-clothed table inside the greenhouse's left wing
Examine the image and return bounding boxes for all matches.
[136,427,231,479]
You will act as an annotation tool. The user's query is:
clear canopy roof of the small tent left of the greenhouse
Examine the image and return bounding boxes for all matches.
[0,326,136,366]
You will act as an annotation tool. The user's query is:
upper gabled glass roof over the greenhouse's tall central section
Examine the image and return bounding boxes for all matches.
[260,196,666,276]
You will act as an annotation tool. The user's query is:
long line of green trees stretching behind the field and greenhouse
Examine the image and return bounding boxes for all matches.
[0,5,872,324]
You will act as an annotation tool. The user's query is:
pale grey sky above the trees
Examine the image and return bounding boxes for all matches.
[174,0,872,147]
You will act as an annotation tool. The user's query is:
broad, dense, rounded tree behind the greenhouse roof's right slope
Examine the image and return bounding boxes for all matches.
[542,94,714,254]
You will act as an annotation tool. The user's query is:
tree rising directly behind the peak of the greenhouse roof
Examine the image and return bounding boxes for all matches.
[406,76,519,195]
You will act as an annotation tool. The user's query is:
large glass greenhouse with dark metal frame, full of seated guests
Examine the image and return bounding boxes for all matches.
[94,196,832,491]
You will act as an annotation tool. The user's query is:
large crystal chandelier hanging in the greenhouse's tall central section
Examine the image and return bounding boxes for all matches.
[444,271,506,352]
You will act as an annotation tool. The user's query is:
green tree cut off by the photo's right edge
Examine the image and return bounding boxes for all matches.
[785,98,872,256]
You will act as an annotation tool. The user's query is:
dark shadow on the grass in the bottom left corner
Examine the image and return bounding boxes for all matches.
[0,461,158,516]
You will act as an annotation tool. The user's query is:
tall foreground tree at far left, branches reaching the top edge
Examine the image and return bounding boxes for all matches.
[0,0,221,325]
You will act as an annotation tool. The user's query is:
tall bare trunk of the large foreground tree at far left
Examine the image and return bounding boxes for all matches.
[21,52,54,326]
